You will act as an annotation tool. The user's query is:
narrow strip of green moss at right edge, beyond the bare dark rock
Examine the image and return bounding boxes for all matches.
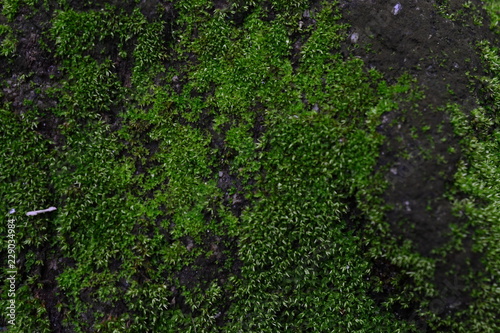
[434,43,500,332]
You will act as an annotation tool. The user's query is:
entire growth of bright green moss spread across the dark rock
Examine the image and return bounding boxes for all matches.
[0,0,500,332]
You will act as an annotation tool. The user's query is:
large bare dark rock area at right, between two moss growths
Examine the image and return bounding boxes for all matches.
[342,0,498,319]
